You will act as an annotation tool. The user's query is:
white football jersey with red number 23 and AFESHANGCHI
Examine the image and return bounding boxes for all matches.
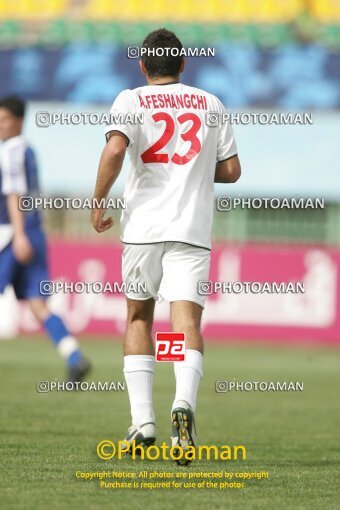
[105,83,237,248]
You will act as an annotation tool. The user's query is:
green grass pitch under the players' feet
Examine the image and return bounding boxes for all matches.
[0,338,340,510]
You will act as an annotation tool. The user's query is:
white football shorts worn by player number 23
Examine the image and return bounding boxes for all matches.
[122,242,210,308]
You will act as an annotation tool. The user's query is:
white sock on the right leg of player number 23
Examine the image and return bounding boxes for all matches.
[172,349,203,412]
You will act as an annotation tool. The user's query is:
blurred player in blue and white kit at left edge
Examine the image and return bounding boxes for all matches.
[0,97,90,382]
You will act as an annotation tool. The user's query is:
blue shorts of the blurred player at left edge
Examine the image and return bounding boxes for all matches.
[0,227,50,299]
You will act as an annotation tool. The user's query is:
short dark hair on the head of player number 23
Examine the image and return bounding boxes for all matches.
[142,28,183,77]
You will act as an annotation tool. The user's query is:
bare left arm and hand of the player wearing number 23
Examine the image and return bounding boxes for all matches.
[91,131,129,232]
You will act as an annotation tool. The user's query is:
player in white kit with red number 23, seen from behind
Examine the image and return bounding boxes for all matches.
[91,29,241,464]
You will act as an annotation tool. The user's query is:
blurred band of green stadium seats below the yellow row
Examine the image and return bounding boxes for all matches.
[0,19,340,48]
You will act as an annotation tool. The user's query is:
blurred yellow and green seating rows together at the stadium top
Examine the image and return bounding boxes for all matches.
[0,0,340,48]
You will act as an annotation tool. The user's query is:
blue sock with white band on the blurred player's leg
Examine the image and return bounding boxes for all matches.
[44,314,82,366]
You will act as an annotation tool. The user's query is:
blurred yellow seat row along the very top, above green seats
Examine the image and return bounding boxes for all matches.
[0,0,340,24]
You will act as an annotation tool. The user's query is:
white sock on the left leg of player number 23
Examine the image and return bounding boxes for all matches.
[124,354,155,425]
